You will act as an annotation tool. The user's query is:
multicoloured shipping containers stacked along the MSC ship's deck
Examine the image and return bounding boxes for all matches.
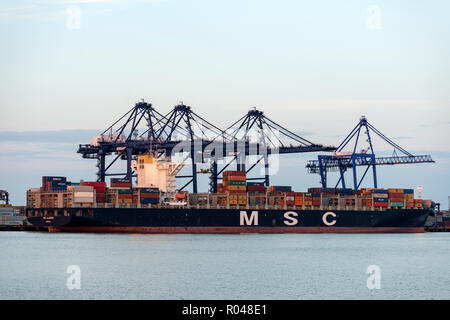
[27,175,433,210]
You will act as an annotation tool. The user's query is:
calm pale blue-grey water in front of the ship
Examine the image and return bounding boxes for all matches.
[0,232,450,299]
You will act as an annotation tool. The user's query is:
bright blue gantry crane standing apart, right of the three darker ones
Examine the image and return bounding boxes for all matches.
[306,116,434,190]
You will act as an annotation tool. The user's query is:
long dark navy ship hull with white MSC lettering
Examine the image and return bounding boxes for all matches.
[27,208,430,234]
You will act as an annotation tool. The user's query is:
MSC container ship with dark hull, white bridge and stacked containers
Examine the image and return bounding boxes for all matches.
[26,153,434,233]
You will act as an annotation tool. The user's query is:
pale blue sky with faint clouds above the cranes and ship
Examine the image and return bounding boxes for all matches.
[0,0,450,207]
